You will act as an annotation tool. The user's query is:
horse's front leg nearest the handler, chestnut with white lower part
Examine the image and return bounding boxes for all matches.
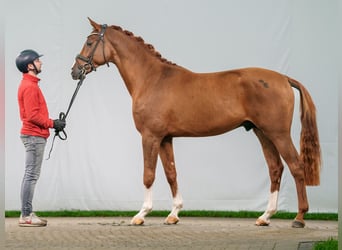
[131,136,160,225]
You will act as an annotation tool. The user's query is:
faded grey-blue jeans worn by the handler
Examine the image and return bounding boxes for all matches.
[20,135,46,216]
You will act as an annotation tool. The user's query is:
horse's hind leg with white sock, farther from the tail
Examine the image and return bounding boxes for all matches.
[254,128,284,226]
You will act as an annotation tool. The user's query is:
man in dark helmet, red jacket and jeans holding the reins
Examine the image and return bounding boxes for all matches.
[15,49,65,227]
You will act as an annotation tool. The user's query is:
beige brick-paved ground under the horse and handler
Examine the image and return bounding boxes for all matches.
[5,217,338,250]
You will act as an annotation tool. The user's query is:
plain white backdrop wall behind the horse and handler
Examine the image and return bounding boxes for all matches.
[5,0,341,212]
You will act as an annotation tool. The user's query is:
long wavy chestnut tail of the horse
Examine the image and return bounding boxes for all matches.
[288,77,321,186]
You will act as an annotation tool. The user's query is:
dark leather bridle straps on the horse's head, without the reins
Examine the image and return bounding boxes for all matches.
[76,24,109,75]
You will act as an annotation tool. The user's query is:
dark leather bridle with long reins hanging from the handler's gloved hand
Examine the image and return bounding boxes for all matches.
[47,24,109,160]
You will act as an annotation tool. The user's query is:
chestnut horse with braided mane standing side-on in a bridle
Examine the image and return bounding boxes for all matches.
[72,19,321,227]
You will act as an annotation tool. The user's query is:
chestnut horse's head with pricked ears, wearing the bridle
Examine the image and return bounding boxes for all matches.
[71,18,109,80]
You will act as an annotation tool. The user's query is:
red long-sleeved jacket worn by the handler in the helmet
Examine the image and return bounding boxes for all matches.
[18,73,53,138]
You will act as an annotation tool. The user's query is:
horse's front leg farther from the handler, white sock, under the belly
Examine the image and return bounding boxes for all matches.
[159,137,183,225]
